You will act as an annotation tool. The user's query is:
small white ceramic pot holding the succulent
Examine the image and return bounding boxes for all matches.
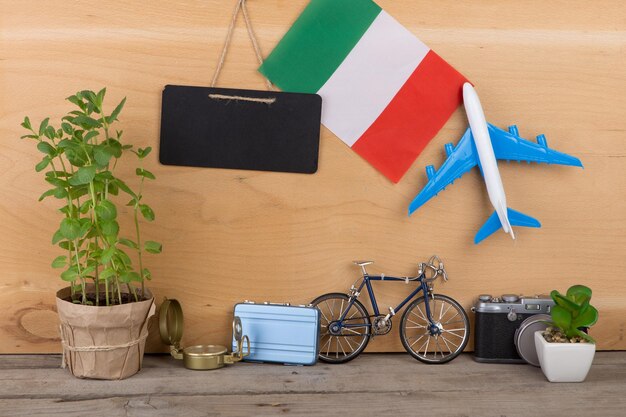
[535,331,596,382]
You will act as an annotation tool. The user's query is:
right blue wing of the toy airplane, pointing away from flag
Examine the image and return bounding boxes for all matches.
[487,123,583,167]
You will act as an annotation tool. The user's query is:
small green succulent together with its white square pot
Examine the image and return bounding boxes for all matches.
[535,285,598,382]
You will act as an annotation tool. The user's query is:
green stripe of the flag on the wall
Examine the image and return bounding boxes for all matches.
[259,0,381,93]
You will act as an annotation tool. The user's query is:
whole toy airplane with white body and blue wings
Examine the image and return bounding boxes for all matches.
[409,83,583,243]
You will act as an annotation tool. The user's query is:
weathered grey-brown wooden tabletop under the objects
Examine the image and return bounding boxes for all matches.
[0,352,626,417]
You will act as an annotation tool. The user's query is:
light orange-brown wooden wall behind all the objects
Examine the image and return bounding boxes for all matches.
[0,0,626,353]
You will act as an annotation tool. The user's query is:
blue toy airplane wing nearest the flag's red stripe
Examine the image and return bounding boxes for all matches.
[409,128,478,215]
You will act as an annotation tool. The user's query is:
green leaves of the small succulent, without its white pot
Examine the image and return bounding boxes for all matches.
[550,285,598,343]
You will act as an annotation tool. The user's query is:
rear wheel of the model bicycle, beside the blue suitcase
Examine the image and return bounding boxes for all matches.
[311,293,370,363]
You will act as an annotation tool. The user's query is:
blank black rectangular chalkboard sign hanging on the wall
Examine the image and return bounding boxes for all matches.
[159,85,322,174]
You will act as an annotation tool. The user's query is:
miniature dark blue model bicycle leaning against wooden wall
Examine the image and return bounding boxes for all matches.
[311,255,469,364]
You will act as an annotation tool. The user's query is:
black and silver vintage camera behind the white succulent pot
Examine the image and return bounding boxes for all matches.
[472,294,554,363]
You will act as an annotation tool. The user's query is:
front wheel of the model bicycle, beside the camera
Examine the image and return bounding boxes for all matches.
[400,294,470,364]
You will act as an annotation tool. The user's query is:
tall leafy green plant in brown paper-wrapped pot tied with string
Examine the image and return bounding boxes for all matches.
[22,89,161,379]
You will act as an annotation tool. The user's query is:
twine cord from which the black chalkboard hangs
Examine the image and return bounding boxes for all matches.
[209,0,276,104]
